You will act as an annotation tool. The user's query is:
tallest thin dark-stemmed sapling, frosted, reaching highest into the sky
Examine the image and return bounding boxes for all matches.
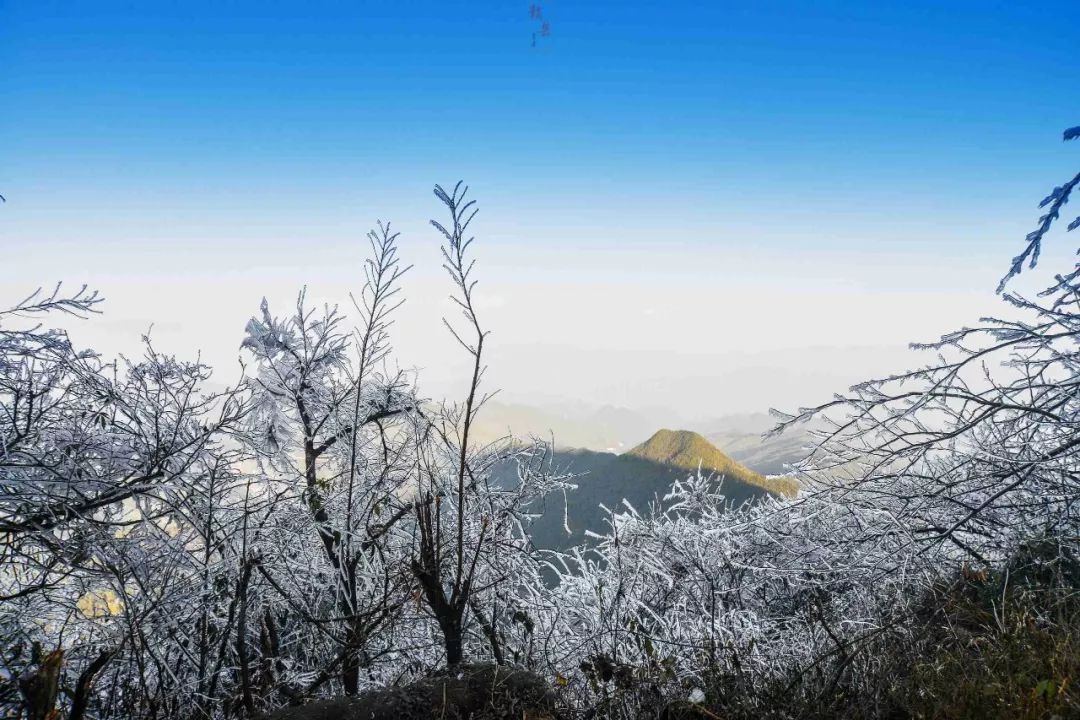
[410,182,564,666]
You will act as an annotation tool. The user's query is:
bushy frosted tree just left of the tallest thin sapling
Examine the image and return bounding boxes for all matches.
[244,225,418,694]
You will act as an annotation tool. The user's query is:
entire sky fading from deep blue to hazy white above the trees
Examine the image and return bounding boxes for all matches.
[0,0,1080,415]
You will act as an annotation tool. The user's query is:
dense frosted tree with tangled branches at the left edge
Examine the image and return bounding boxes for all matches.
[0,287,246,718]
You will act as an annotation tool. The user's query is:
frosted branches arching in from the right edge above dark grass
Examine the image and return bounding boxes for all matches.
[784,128,1080,562]
